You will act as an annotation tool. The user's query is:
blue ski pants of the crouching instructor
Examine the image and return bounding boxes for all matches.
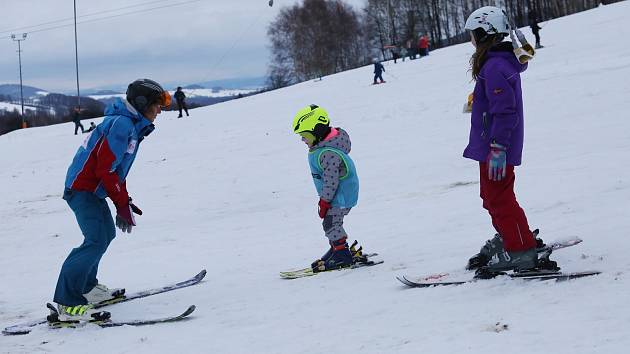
[54,189,116,306]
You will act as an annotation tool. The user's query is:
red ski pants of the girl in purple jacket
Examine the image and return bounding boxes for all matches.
[479,162,536,251]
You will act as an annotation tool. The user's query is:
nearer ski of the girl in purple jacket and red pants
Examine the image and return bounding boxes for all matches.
[396,271,601,288]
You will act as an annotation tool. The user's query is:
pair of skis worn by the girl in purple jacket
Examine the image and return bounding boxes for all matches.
[396,237,601,288]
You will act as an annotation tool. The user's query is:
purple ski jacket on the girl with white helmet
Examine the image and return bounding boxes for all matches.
[464,42,527,166]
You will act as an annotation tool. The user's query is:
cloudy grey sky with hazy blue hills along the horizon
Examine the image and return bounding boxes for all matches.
[0,0,365,92]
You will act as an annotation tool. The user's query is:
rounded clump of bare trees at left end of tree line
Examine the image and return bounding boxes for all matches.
[267,0,369,87]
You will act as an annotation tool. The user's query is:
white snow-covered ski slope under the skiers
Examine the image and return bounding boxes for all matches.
[0,1,630,354]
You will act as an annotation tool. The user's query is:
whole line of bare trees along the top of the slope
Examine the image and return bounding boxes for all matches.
[267,0,622,88]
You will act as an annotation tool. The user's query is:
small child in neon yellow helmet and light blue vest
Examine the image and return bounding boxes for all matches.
[293,104,366,272]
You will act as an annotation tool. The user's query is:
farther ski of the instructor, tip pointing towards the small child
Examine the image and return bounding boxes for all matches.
[2,269,207,335]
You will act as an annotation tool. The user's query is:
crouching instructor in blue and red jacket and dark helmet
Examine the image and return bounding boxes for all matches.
[54,79,171,321]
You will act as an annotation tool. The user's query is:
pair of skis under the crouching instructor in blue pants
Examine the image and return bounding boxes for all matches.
[2,269,207,335]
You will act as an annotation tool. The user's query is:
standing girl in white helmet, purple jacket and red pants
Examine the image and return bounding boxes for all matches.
[464,6,551,277]
